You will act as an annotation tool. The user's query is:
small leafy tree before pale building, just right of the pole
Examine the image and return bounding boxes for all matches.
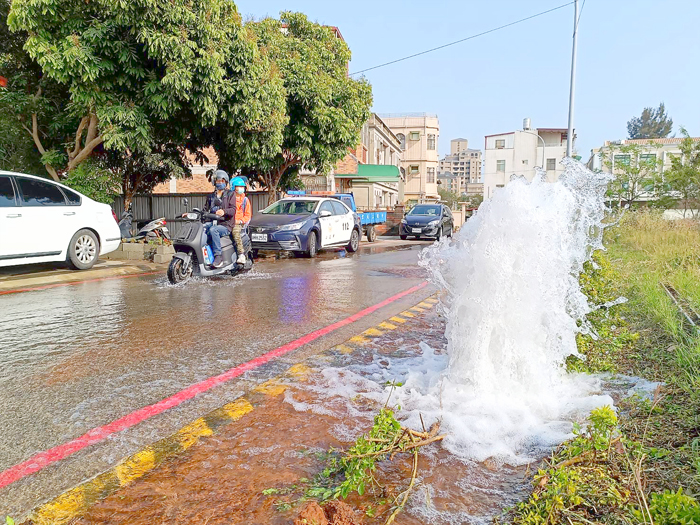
[601,141,663,206]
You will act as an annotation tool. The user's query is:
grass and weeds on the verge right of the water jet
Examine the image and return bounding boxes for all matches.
[499,211,700,525]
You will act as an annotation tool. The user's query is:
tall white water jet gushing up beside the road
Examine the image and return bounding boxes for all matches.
[399,159,612,464]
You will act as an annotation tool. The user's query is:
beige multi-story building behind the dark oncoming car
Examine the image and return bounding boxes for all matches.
[379,113,440,204]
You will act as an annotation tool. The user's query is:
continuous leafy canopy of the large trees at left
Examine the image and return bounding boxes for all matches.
[0,5,371,207]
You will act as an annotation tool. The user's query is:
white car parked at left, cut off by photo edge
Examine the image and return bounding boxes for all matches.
[0,171,121,270]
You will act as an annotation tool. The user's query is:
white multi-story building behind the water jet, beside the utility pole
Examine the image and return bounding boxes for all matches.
[483,119,576,199]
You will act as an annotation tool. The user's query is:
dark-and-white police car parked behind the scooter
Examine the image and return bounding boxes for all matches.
[250,196,362,257]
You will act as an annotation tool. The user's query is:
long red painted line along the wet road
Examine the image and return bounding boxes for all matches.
[0,281,428,489]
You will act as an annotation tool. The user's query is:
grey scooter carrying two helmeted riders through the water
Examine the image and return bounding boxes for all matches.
[168,208,253,284]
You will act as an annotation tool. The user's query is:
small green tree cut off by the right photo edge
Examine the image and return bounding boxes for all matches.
[665,128,700,218]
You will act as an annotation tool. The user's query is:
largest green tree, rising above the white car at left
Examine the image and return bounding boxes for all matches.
[7,0,254,178]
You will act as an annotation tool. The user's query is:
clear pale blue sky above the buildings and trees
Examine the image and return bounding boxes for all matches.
[236,0,700,160]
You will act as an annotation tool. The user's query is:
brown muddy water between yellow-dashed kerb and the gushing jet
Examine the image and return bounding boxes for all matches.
[77,311,529,525]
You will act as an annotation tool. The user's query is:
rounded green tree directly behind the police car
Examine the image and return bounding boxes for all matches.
[217,12,372,202]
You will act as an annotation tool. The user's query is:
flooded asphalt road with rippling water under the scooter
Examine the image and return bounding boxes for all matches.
[0,245,429,515]
